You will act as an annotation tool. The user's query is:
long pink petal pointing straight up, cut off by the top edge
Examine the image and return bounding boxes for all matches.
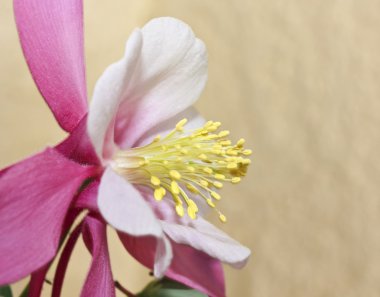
[14,0,87,131]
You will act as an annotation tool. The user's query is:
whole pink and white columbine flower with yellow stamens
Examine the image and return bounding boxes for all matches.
[0,0,251,297]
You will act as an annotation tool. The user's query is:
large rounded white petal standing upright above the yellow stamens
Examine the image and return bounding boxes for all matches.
[115,17,207,146]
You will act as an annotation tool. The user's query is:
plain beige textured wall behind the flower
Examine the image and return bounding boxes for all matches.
[0,0,380,297]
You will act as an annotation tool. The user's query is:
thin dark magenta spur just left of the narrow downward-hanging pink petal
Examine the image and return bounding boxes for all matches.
[52,223,82,297]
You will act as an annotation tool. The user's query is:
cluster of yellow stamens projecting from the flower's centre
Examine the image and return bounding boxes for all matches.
[113,119,252,222]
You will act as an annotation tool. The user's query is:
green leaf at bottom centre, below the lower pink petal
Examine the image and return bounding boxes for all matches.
[137,278,207,297]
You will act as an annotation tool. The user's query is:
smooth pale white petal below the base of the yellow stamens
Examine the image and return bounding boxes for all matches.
[98,167,163,237]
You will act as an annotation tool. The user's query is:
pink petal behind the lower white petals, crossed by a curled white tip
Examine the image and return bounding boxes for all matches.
[118,232,225,297]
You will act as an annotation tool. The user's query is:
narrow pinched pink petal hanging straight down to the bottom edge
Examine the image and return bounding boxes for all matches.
[81,216,115,297]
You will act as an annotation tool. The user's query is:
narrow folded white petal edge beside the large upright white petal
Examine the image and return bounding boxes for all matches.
[88,29,142,159]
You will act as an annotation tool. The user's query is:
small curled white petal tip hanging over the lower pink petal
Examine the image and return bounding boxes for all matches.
[154,236,173,278]
